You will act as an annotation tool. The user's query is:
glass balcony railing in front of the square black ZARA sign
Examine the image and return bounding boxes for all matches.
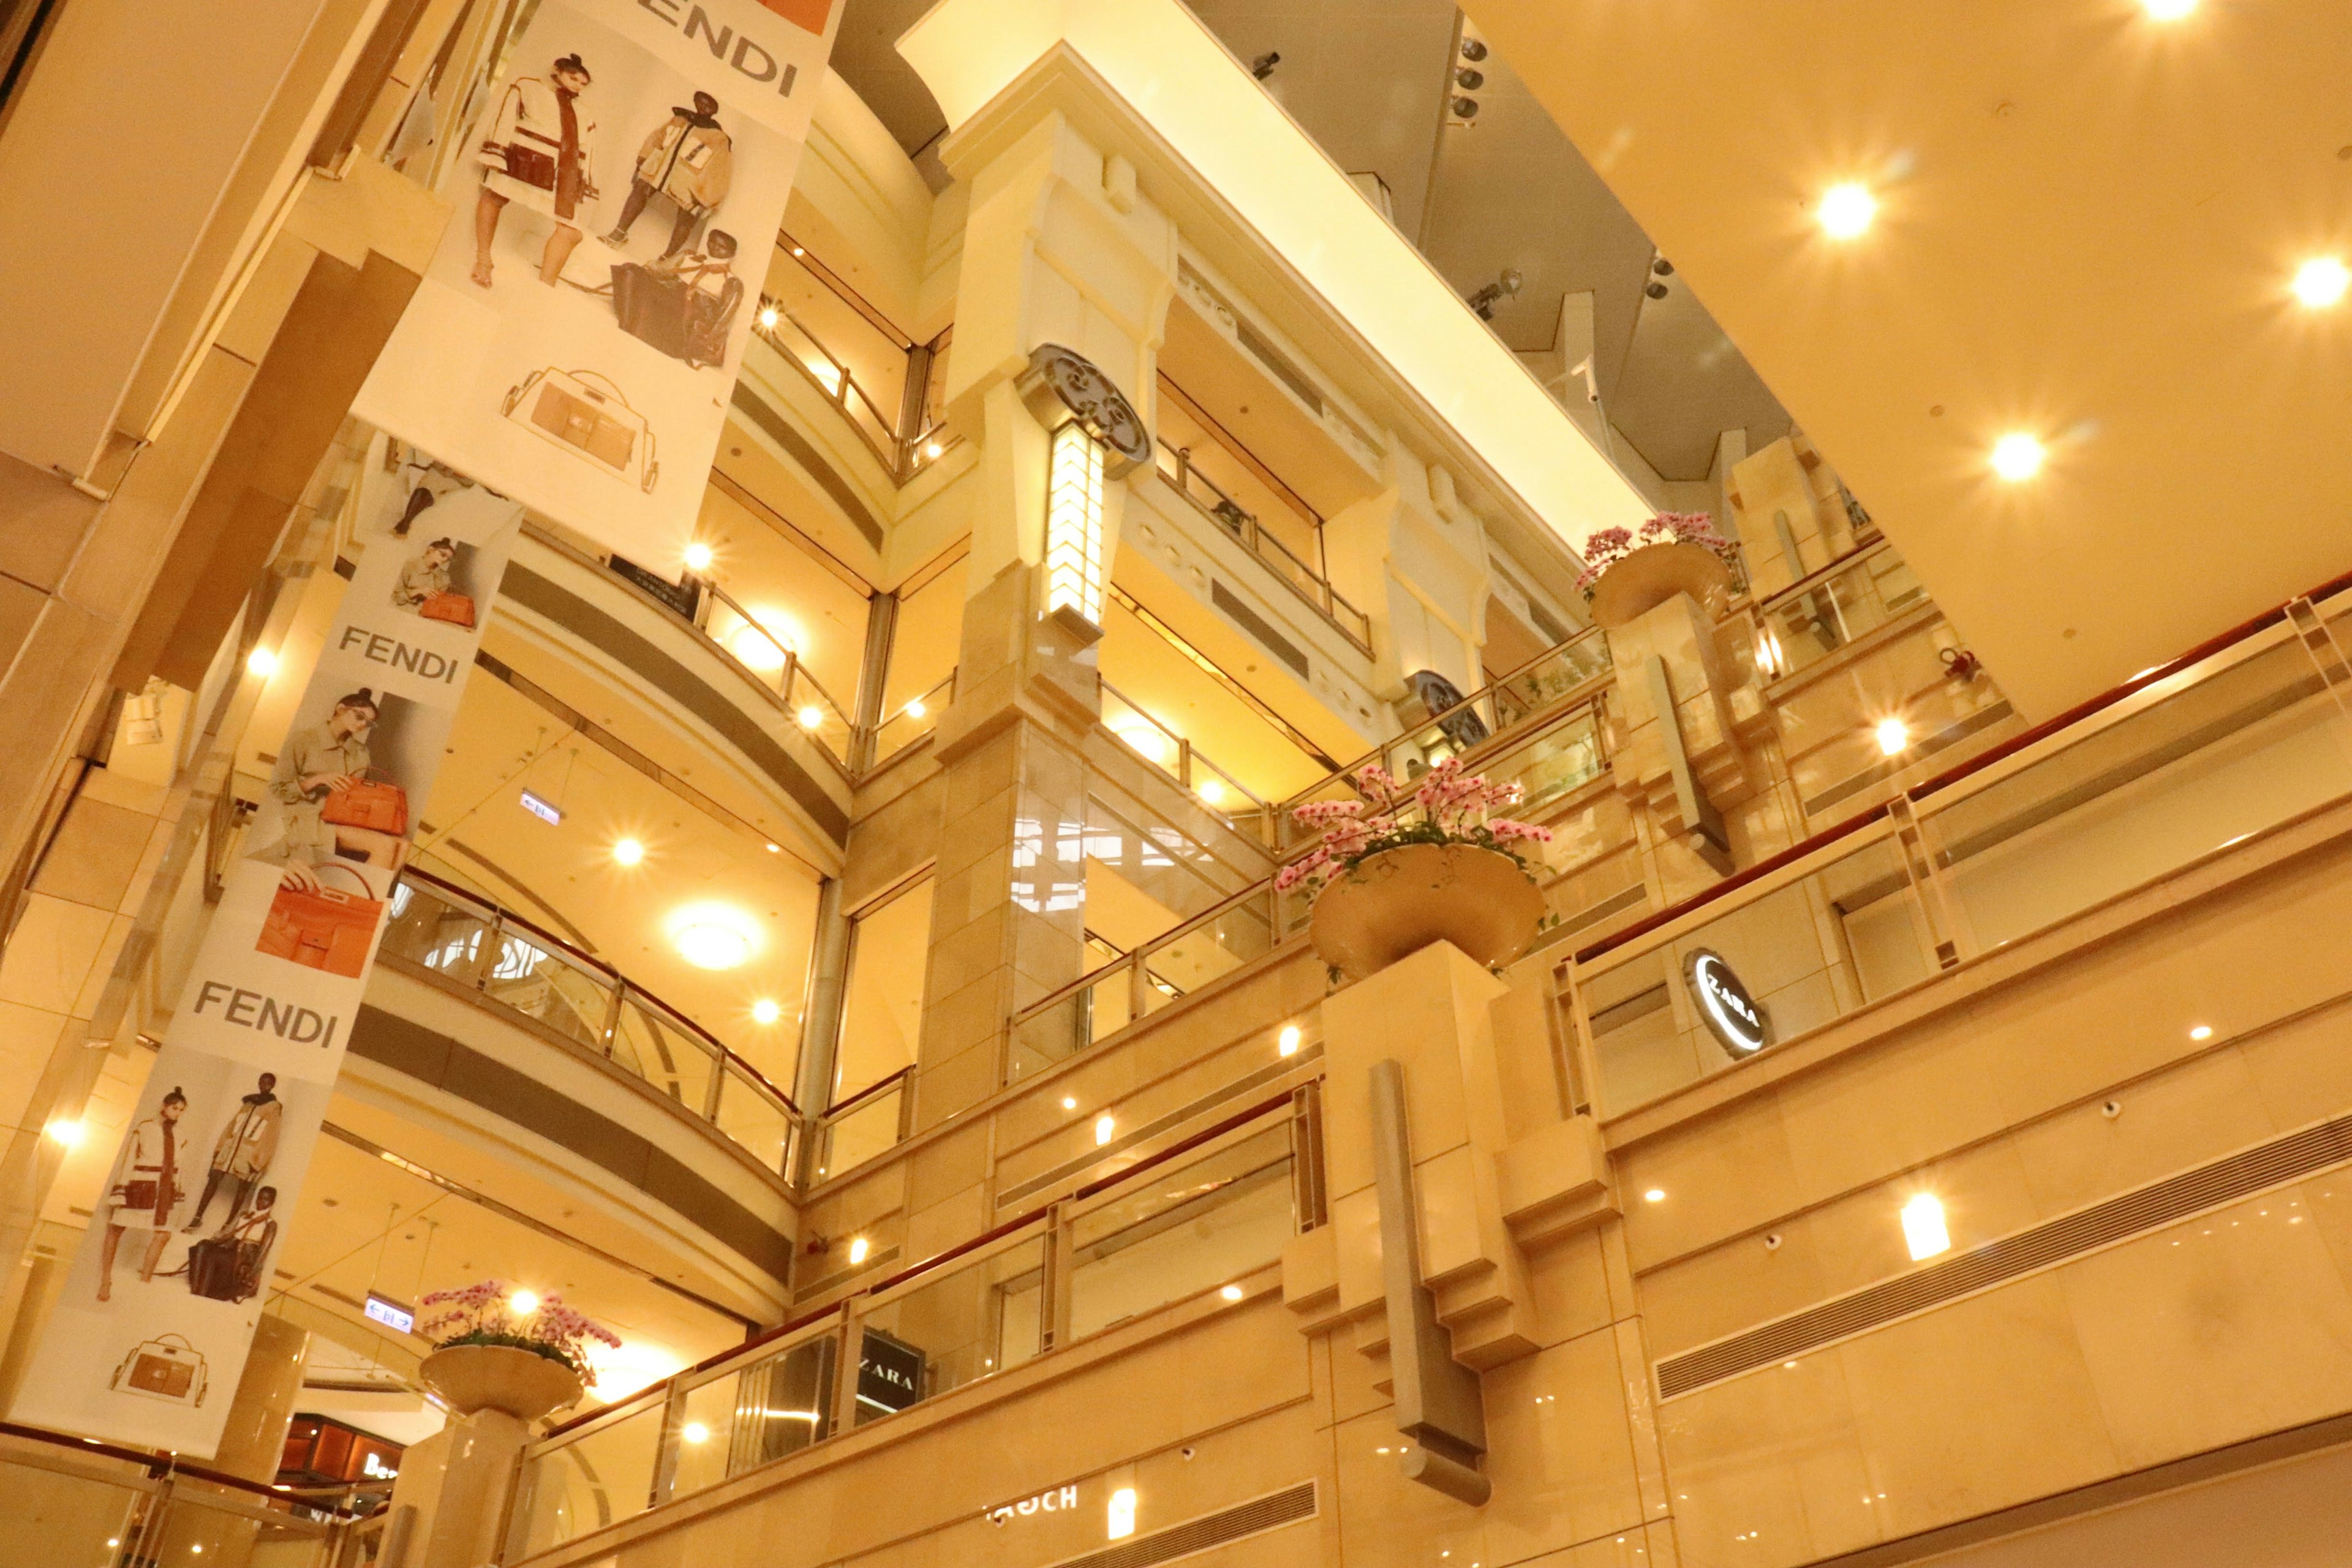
[503,1090,1324,1563]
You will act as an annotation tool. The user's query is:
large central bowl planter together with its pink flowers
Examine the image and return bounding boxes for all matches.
[1275,757,1552,978]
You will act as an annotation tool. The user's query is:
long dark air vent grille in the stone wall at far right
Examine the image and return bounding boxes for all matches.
[1658,1117,2352,1399]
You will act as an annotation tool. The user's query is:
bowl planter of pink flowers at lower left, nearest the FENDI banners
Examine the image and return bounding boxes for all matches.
[417,1279,621,1420]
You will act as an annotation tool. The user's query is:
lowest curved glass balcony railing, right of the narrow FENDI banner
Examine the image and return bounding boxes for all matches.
[381,867,800,1178]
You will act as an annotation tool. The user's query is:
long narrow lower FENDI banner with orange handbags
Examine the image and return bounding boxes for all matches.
[9,456,522,1458]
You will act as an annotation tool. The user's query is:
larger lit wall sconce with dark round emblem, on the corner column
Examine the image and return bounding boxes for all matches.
[1021,343,1153,642]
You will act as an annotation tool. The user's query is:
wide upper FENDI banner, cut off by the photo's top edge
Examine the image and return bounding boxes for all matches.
[353,0,840,573]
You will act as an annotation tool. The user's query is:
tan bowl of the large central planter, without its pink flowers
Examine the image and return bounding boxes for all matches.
[1308,844,1543,980]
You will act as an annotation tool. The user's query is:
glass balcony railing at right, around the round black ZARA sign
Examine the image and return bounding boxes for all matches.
[1571,562,2352,1114]
